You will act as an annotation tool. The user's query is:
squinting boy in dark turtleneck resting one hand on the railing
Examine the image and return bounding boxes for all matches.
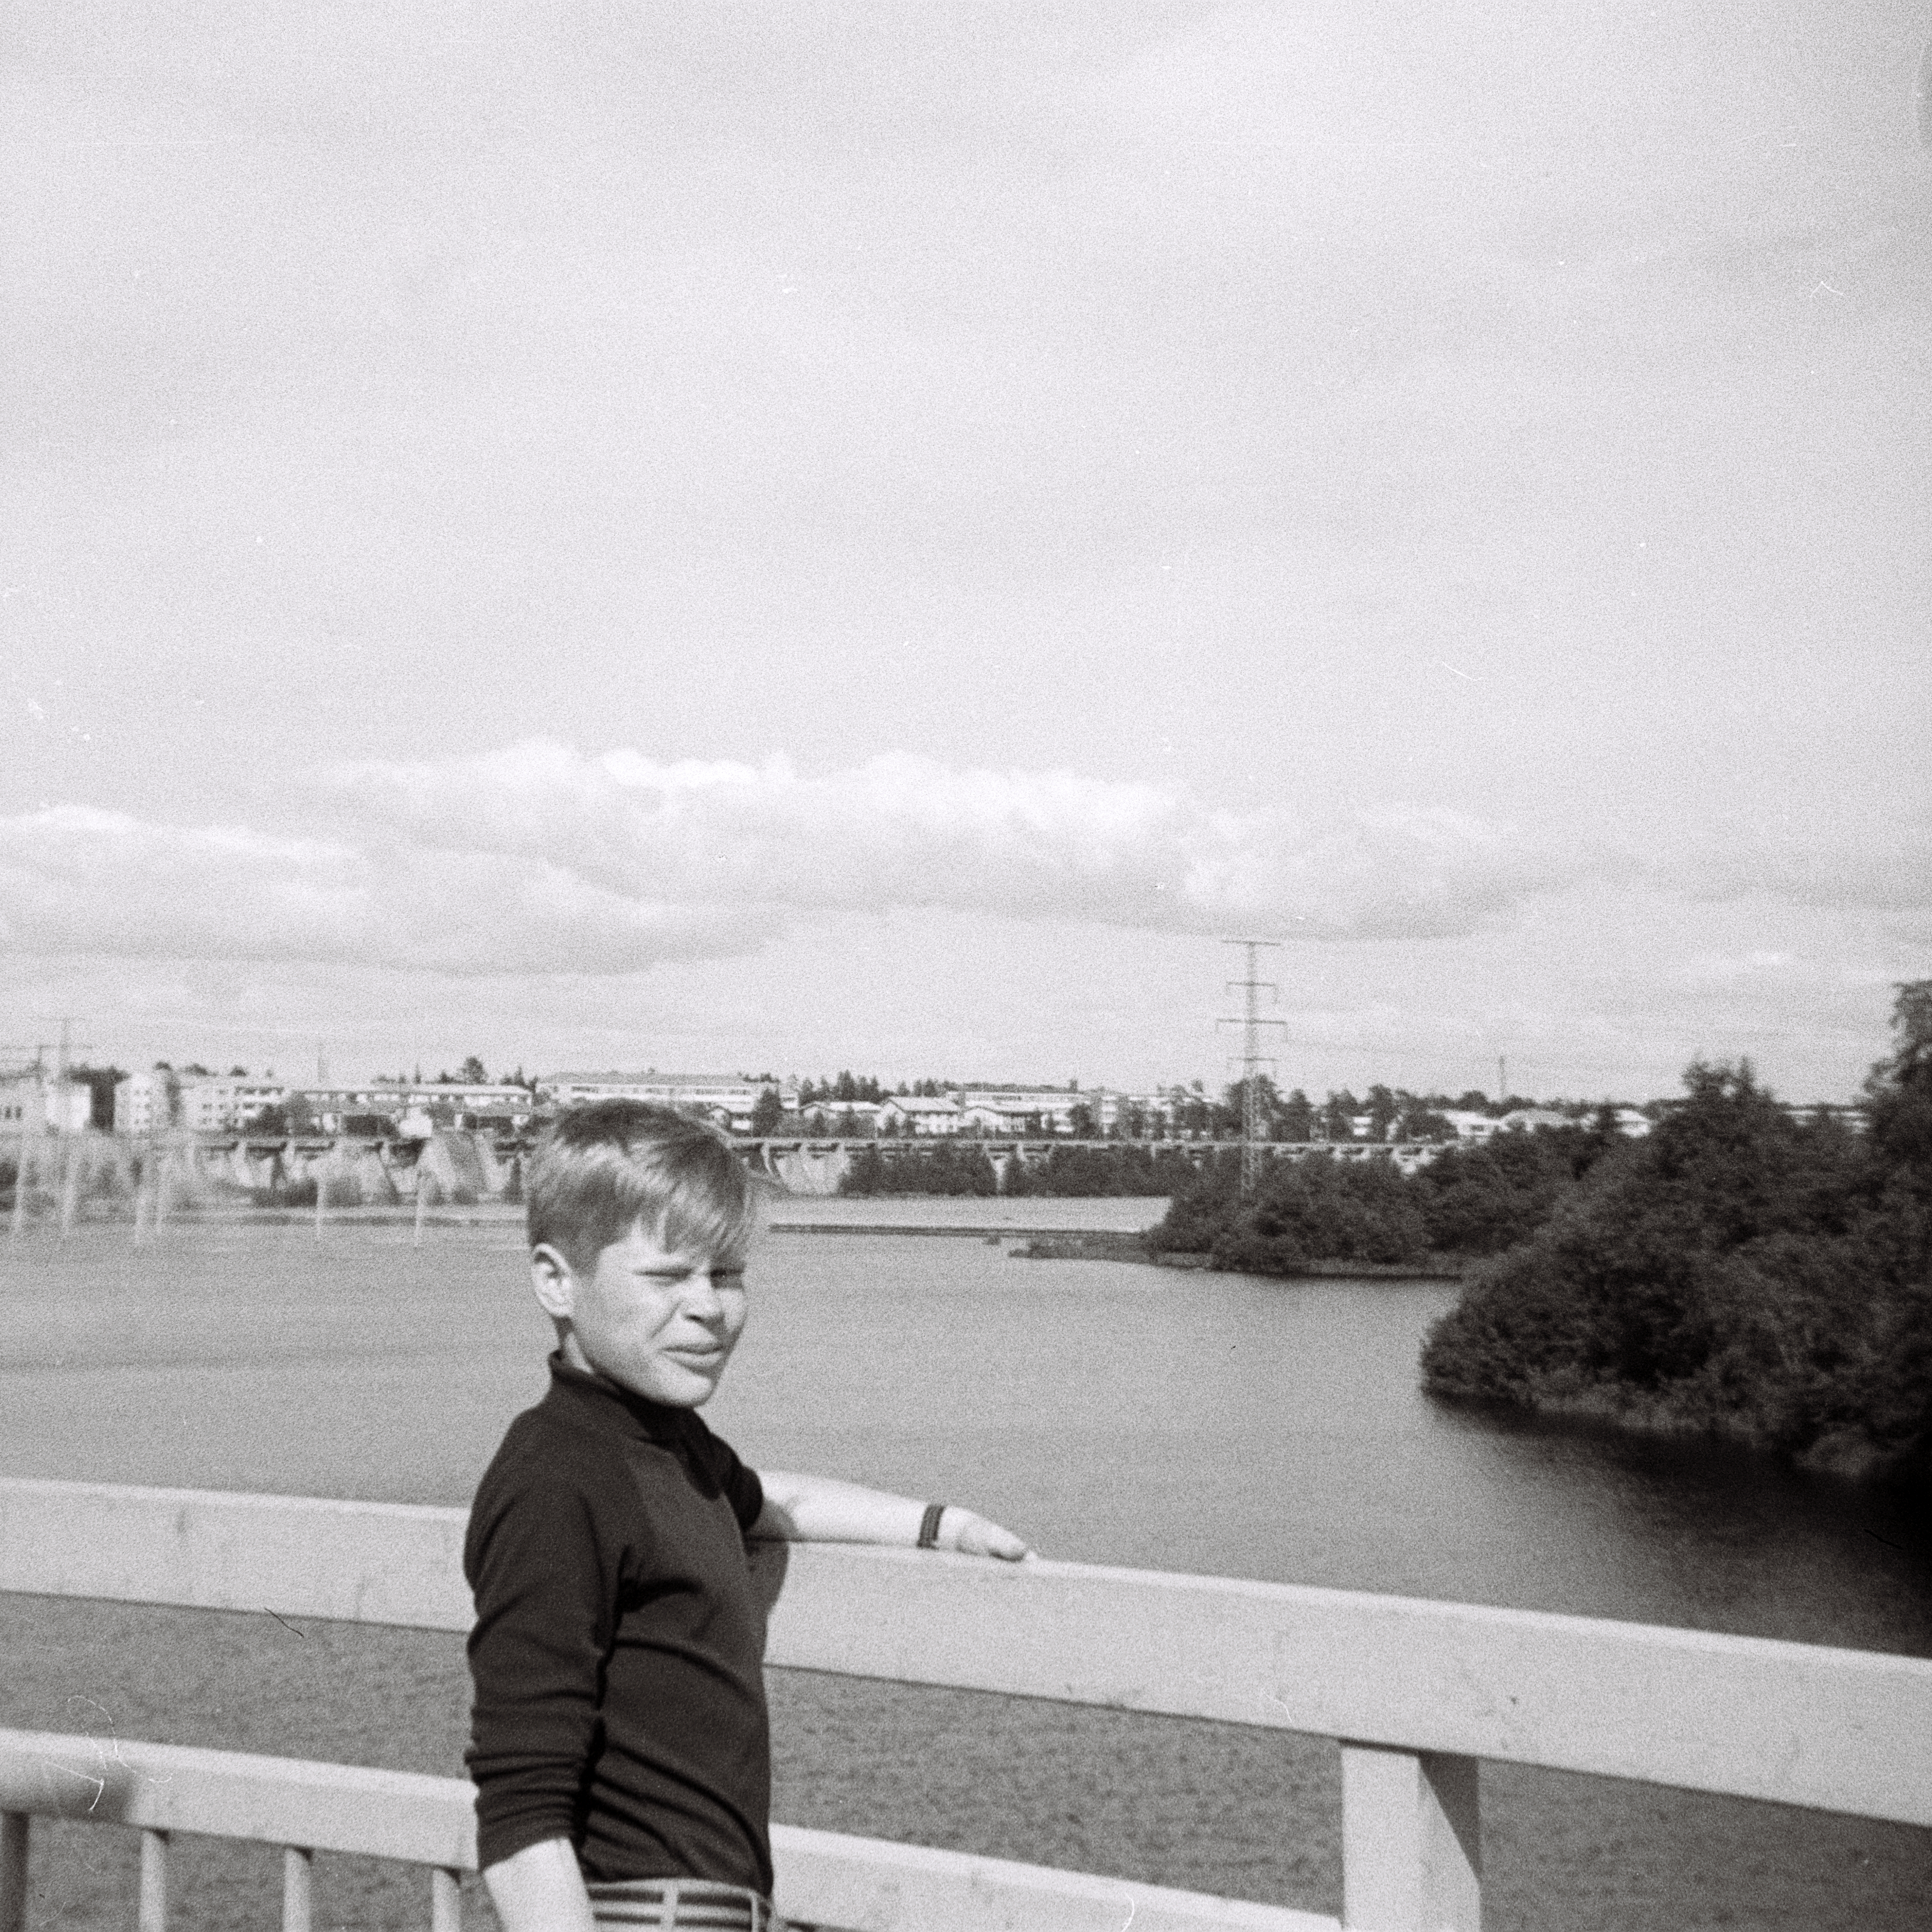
[464,1101,1028,1932]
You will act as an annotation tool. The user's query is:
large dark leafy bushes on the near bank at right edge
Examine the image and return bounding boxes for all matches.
[1422,982,1932,1484]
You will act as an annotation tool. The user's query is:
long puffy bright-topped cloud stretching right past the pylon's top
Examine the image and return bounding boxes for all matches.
[322,740,1584,939]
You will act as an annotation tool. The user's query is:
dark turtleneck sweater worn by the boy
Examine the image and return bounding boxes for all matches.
[464,1356,771,1897]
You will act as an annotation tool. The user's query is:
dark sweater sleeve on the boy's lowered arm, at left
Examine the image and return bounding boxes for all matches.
[464,1467,620,1868]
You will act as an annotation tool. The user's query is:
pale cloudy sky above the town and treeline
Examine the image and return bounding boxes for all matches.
[0,0,1932,1099]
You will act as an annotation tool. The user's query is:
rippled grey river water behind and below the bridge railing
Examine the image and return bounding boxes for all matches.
[0,1200,1932,1932]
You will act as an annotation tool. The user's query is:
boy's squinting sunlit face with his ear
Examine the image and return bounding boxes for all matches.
[545,1223,744,1408]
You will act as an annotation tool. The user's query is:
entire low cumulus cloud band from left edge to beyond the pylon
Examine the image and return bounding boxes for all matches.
[0,742,1599,974]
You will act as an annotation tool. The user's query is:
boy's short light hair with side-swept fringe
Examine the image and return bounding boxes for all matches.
[527,1099,757,1269]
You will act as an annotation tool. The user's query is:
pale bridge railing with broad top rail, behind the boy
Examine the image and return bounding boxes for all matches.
[0,1482,1932,1932]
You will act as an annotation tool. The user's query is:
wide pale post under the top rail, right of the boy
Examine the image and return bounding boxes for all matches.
[1341,1739,1482,1932]
